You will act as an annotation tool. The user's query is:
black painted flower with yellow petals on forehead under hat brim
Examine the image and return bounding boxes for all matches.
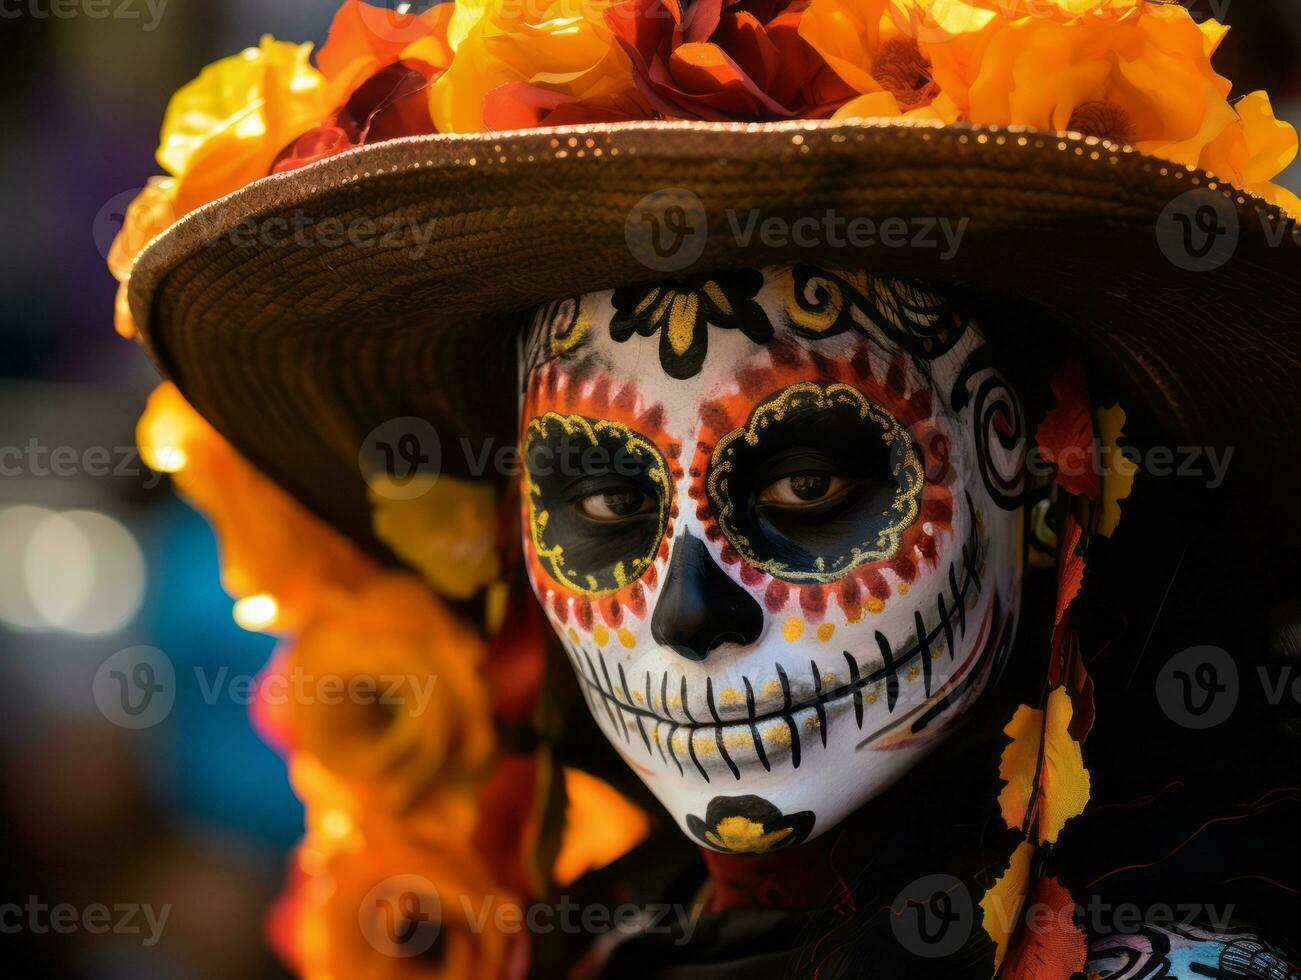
[610,269,773,380]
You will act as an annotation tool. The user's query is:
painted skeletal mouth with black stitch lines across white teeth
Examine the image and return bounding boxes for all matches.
[566,504,983,782]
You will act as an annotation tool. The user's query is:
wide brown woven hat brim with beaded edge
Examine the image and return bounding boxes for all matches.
[129,120,1301,553]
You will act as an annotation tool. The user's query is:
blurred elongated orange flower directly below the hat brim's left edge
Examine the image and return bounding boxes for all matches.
[135,381,377,631]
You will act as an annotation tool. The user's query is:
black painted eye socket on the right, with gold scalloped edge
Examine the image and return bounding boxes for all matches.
[705,381,924,582]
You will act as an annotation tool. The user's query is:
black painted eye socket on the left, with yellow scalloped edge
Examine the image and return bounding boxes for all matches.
[524,413,673,597]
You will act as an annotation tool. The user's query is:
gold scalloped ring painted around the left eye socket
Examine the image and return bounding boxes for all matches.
[524,411,673,599]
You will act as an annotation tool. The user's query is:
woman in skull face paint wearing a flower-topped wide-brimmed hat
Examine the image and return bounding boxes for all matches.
[114,0,1301,977]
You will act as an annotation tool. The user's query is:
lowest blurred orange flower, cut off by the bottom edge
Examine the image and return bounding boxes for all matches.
[288,826,528,980]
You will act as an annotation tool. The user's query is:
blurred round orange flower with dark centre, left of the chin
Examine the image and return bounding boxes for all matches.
[291,574,493,810]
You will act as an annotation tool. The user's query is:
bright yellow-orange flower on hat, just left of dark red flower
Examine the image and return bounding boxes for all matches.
[429,0,634,133]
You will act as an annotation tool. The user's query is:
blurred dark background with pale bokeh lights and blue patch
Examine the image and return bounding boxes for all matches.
[0,0,1301,977]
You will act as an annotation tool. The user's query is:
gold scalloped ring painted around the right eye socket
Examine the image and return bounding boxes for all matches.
[705,381,926,583]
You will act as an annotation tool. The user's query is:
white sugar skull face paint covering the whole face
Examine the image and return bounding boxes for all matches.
[520,267,1024,852]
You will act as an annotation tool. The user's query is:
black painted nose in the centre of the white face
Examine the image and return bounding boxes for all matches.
[651,534,764,660]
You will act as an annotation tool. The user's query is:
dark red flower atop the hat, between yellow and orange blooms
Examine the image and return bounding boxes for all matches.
[606,0,853,121]
